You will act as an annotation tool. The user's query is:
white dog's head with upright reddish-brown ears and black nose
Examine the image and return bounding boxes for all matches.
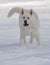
[20,9,33,27]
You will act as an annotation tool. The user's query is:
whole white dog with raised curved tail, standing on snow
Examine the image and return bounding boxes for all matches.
[8,7,40,44]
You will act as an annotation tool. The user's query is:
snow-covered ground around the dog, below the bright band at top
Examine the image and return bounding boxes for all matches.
[0,0,50,65]
